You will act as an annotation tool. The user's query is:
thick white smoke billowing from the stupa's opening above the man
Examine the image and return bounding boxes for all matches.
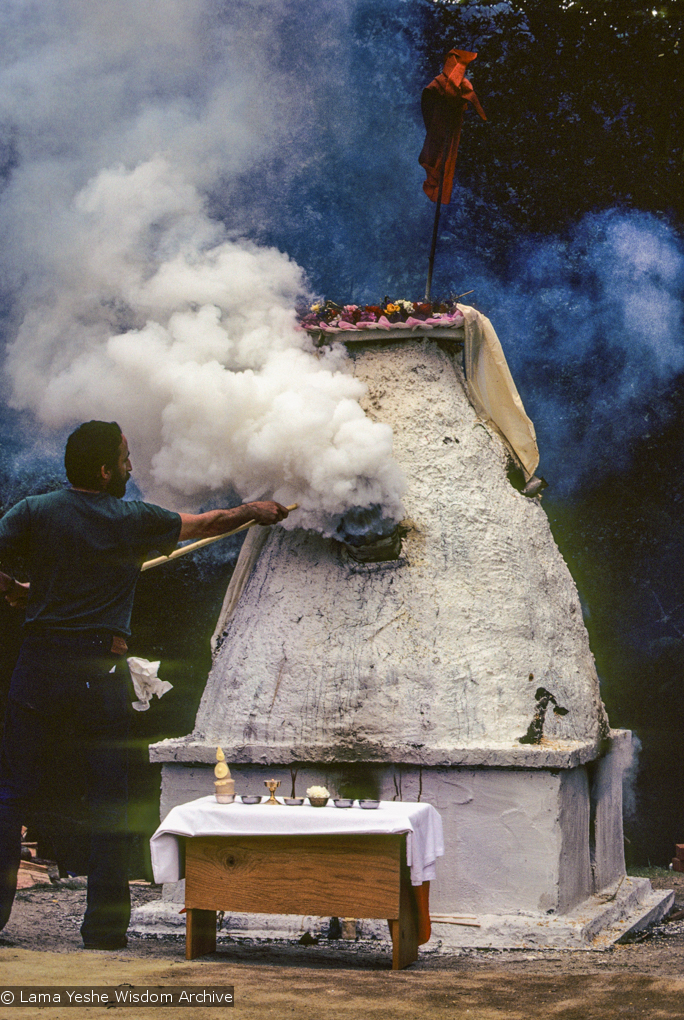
[0,0,404,531]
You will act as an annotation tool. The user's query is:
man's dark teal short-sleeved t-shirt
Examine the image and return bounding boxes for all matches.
[0,489,180,636]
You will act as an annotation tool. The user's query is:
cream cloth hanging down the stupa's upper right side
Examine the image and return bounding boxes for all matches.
[458,305,539,481]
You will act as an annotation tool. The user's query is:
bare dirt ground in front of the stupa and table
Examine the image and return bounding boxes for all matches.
[0,872,684,1020]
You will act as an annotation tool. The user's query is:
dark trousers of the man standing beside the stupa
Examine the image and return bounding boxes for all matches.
[0,630,130,945]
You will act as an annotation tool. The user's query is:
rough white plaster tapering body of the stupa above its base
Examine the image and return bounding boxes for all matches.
[162,341,606,763]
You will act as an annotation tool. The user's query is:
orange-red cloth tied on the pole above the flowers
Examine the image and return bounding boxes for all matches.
[418,50,487,205]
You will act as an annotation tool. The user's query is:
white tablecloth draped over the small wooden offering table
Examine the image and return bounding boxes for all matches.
[150,795,444,885]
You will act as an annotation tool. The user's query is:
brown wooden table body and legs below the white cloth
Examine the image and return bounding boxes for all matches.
[186,833,418,970]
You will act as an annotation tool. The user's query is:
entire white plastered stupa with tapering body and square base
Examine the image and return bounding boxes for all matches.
[146,308,672,951]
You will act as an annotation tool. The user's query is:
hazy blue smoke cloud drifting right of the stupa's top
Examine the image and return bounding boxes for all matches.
[462,210,684,496]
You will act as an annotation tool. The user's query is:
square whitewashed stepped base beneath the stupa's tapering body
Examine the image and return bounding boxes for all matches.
[140,730,674,952]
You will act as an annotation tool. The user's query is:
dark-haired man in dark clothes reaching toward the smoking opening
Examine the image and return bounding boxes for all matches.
[0,421,287,950]
